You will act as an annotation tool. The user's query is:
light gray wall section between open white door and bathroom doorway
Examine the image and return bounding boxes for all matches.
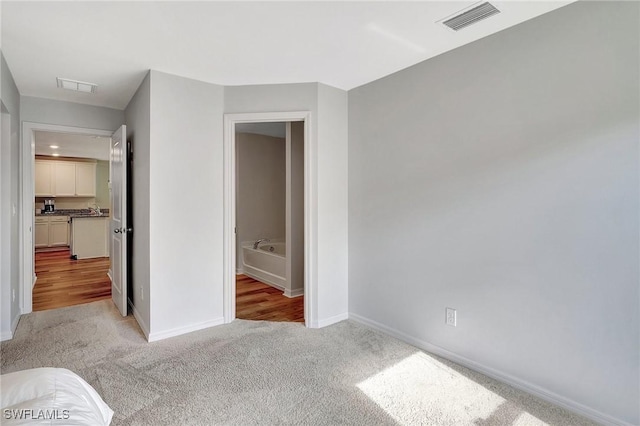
[148,71,224,339]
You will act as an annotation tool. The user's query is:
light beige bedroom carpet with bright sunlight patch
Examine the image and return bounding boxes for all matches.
[0,301,592,426]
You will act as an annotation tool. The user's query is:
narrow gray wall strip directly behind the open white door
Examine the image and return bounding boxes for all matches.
[125,74,151,337]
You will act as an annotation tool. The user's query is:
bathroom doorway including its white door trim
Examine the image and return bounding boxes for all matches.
[223,111,316,327]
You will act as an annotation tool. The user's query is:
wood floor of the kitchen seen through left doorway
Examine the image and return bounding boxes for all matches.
[33,249,111,311]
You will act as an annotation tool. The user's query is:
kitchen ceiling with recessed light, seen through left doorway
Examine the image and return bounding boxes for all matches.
[35,131,111,160]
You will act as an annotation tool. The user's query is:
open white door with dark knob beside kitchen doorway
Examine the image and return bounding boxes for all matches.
[109,125,129,316]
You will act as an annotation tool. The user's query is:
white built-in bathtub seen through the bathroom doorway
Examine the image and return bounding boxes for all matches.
[242,242,290,296]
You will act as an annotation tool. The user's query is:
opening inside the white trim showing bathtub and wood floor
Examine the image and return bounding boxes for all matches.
[234,121,305,322]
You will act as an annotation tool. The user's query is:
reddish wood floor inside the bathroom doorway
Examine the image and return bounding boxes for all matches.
[236,275,304,322]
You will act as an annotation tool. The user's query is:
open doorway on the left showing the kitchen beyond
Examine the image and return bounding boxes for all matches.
[32,130,111,311]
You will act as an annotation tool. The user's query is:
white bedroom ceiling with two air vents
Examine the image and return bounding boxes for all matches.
[0,0,571,109]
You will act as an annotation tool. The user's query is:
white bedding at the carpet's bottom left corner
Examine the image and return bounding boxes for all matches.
[0,368,113,426]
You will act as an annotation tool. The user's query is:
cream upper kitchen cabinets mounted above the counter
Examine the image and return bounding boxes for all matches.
[35,159,96,197]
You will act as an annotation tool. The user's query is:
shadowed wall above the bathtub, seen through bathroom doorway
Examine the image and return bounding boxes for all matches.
[236,133,286,270]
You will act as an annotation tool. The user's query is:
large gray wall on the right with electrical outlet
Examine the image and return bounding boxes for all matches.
[349,2,640,424]
